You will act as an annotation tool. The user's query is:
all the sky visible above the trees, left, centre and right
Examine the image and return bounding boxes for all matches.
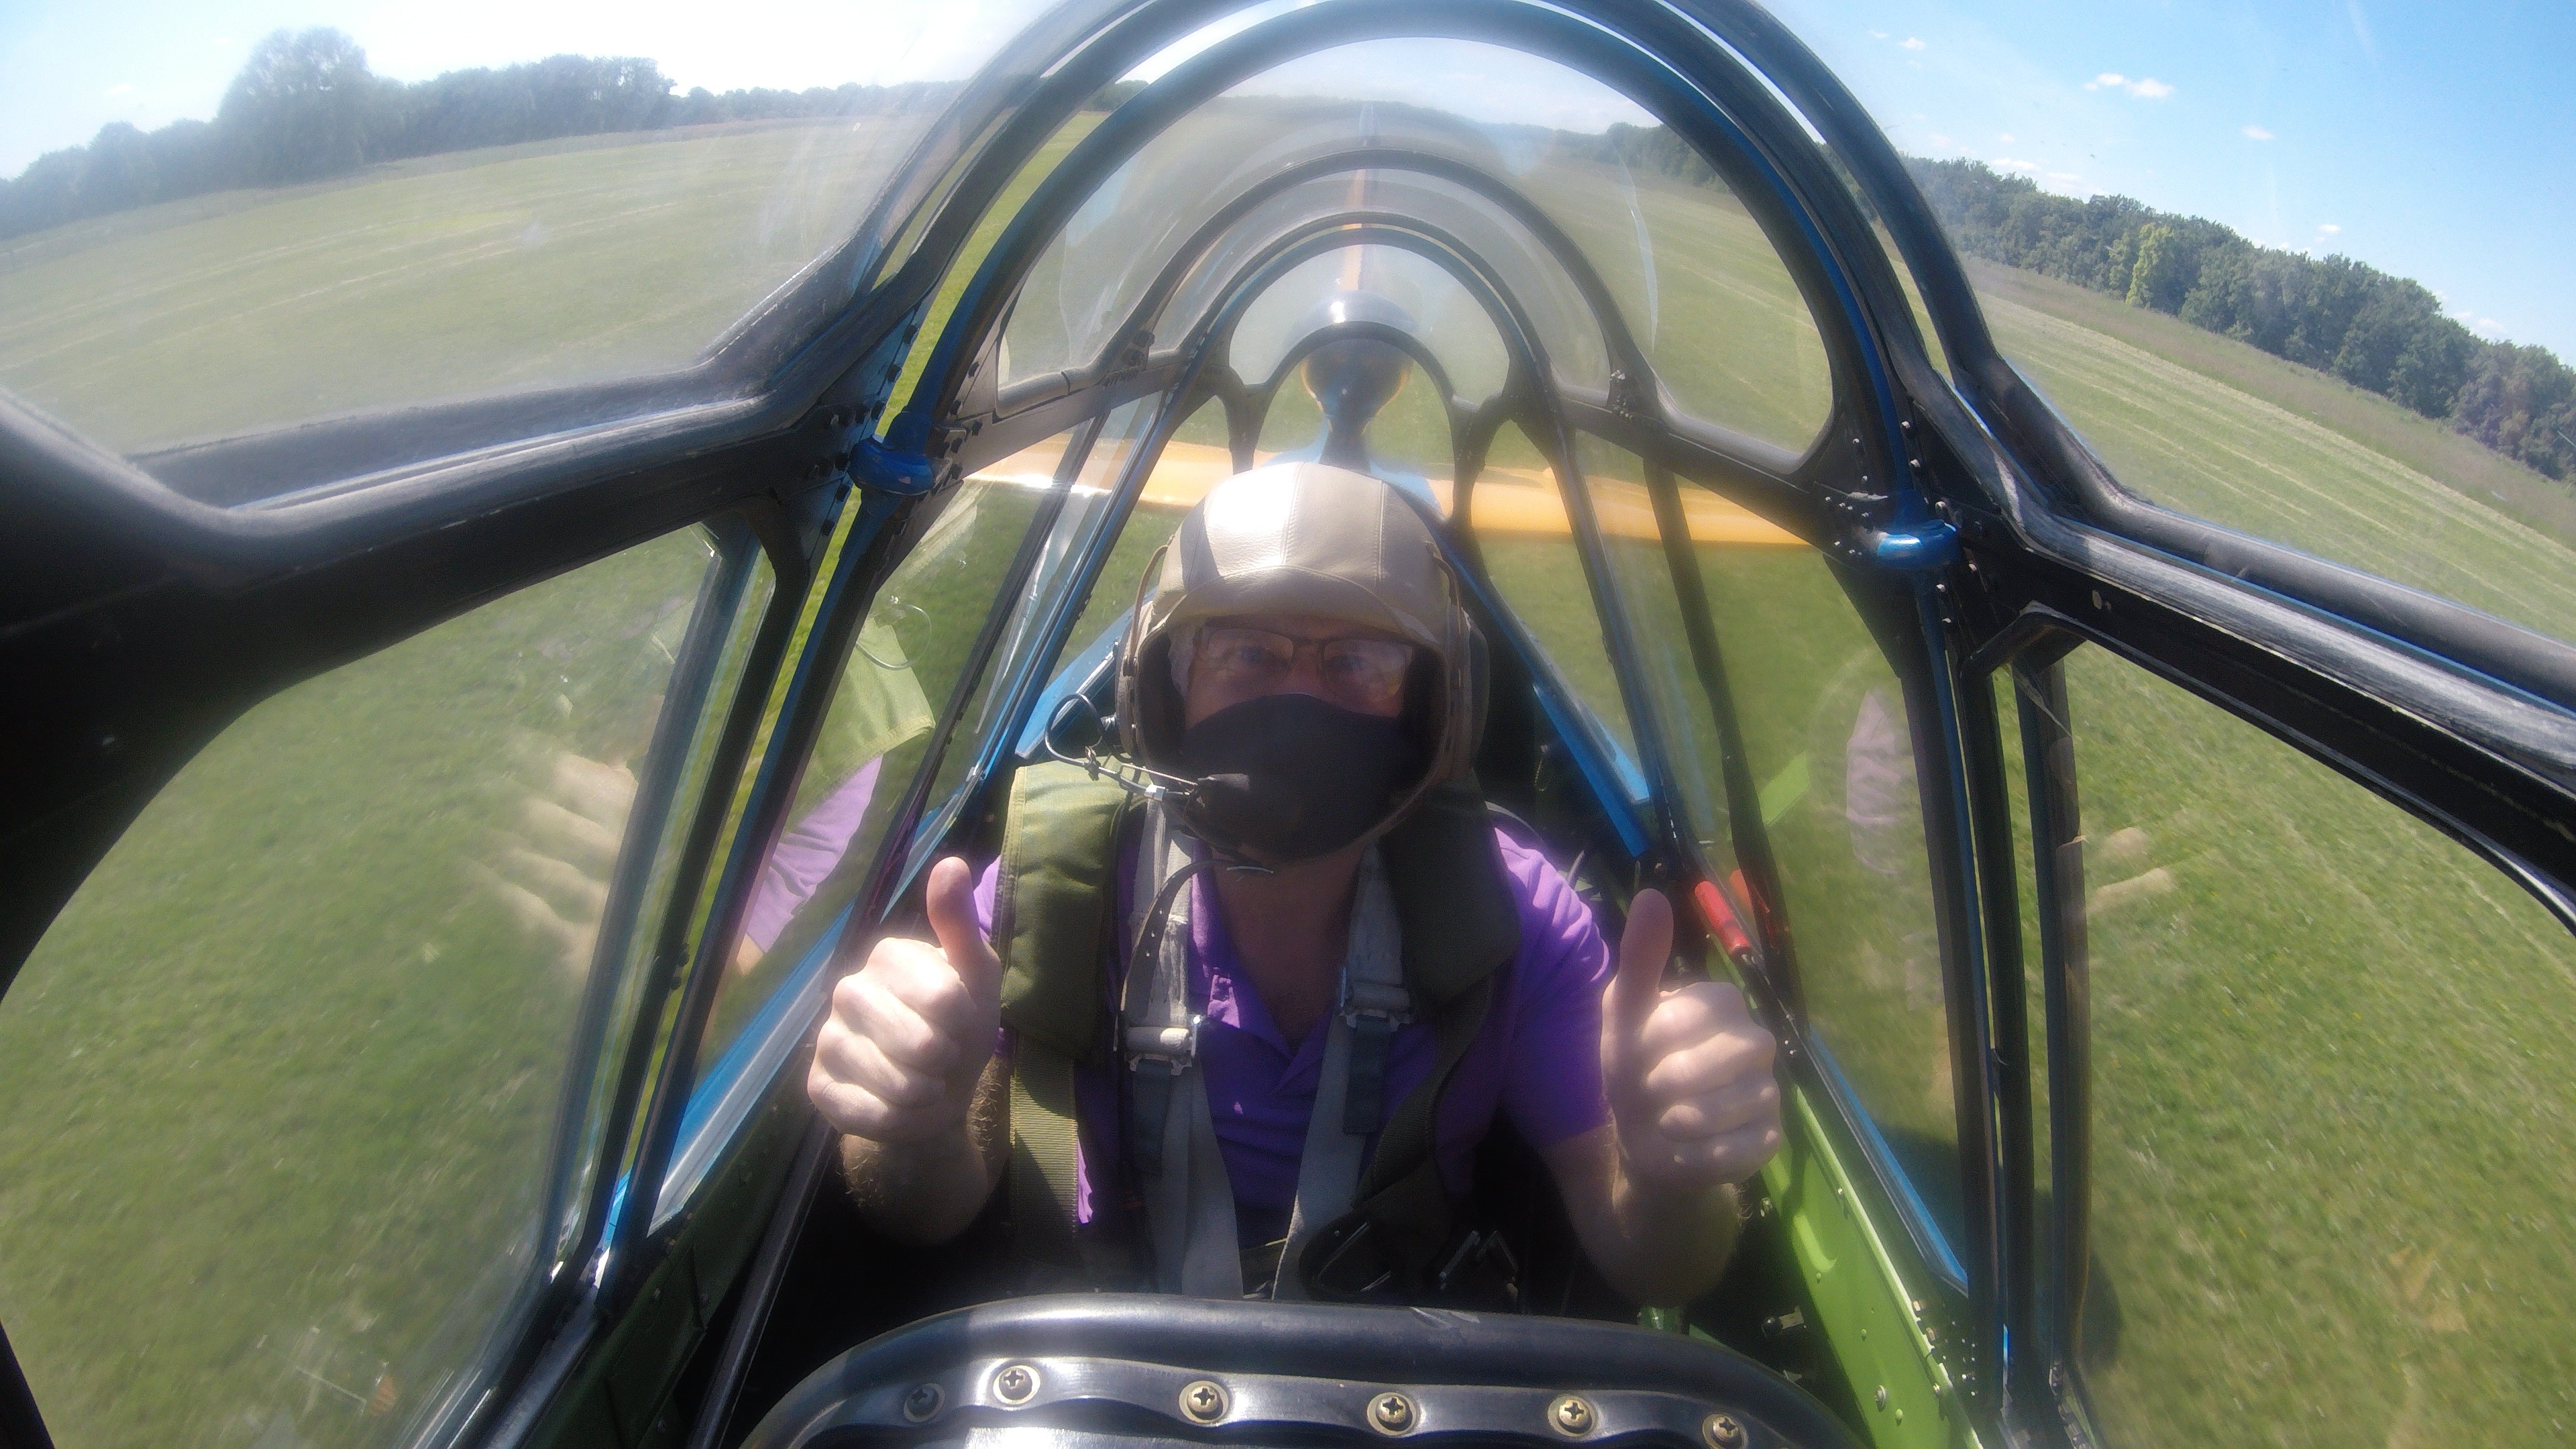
[0,0,2576,361]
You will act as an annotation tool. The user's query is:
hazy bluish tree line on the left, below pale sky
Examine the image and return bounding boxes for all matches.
[0,28,951,237]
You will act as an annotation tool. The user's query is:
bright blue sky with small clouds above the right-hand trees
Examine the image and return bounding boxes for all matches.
[1772,0,2576,361]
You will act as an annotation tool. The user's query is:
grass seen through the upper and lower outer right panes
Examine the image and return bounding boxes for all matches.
[1973,266,2576,1446]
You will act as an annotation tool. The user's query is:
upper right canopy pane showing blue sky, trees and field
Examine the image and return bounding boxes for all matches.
[1775,0,2576,655]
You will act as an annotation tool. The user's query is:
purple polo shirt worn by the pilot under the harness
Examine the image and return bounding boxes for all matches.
[974,830,1610,1243]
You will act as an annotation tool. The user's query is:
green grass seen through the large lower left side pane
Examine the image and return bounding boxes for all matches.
[0,534,708,1444]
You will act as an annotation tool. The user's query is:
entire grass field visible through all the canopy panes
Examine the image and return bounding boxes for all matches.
[0,107,2576,1449]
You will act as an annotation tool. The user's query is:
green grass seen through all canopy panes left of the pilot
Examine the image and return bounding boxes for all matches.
[0,113,1067,1444]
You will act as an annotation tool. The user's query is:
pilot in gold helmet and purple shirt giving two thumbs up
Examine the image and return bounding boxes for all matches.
[809,462,1780,1305]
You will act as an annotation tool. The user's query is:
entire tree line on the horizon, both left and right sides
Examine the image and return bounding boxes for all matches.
[0,39,2576,480]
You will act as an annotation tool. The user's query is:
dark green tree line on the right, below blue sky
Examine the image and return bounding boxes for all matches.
[1589,123,2576,480]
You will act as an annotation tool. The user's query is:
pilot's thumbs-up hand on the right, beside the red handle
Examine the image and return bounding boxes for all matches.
[1602,890,1780,1191]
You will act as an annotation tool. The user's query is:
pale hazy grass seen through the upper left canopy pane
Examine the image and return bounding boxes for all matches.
[0,121,910,451]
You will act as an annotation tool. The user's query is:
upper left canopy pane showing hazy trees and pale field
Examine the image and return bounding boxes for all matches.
[0,0,1038,484]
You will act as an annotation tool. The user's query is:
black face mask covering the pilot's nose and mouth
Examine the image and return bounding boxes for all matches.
[1180,694,1422,864]
